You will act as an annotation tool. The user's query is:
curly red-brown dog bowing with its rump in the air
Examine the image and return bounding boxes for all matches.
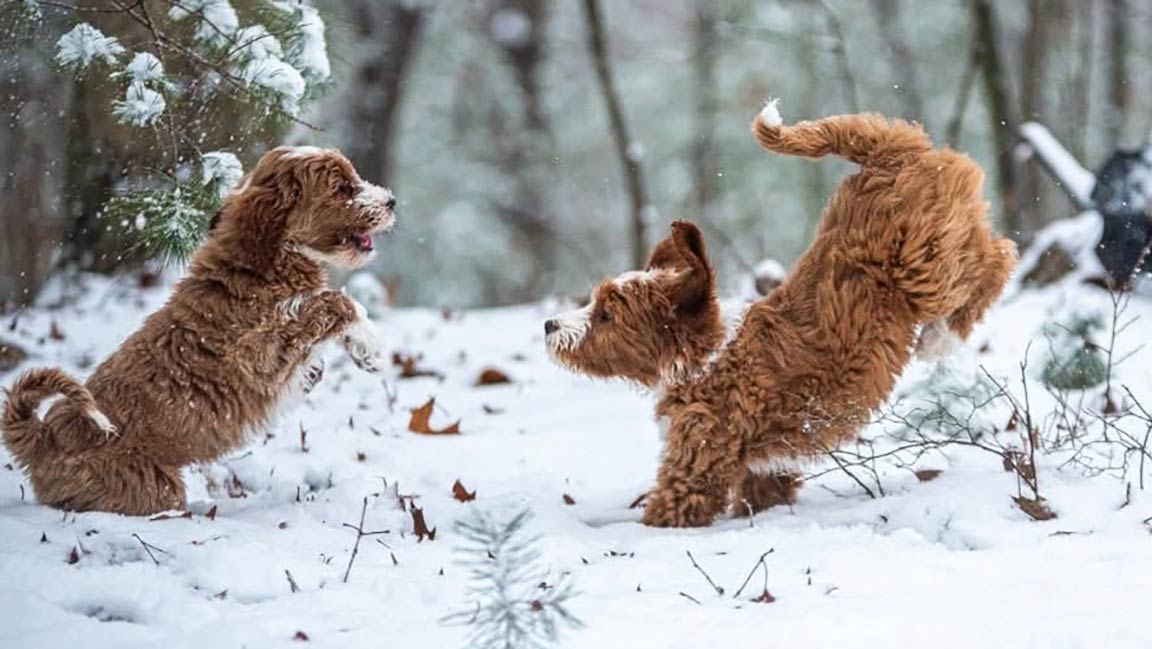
[545,104,1016,527]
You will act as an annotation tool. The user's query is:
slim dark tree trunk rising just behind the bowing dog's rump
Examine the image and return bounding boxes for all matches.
[970,0,1023,240]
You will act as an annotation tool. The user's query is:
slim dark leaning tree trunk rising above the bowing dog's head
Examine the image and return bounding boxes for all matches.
[584,0,647,269]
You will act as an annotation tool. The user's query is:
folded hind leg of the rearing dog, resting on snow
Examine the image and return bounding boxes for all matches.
[31,450,185,515]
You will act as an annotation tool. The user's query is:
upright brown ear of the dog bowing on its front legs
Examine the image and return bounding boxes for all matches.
[647,220,715,314]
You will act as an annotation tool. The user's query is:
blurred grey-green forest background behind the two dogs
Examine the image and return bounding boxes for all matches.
[0,0,1152,309]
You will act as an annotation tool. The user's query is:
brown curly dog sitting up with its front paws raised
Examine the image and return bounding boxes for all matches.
[2,146,395,514]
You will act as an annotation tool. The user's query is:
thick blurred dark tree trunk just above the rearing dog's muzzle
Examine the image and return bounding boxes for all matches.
[343,0,424,182]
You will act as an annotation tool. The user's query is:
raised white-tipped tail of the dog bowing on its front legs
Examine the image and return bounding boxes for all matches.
[752,99,932,165]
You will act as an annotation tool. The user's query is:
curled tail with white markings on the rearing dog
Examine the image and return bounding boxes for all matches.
[0,368,116,468]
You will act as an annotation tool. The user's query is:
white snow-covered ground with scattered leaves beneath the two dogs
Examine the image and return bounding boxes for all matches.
[0,279,1152,649]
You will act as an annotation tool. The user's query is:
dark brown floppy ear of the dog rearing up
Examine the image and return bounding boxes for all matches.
[218,149,301,274]
